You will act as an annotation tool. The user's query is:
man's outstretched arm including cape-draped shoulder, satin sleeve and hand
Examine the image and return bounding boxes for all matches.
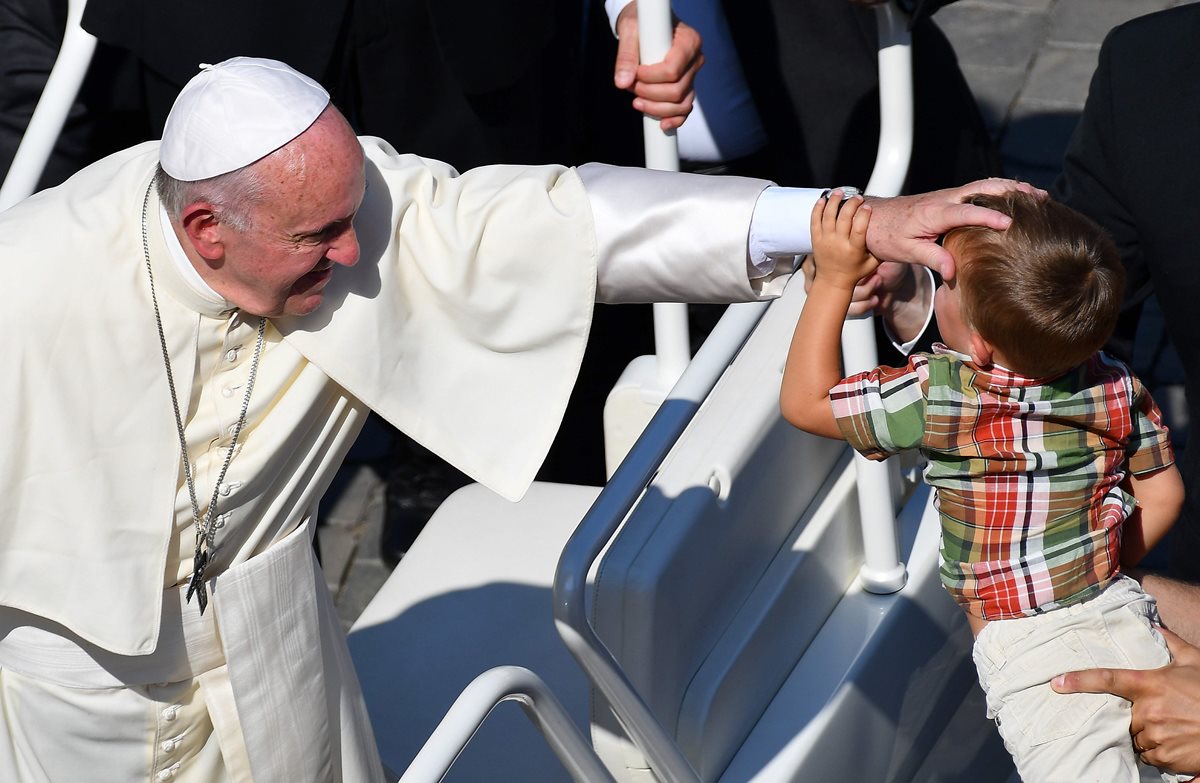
[277,139,1032,498]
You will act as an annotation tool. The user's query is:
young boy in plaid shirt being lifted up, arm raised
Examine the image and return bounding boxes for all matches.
[780,191,1188,783]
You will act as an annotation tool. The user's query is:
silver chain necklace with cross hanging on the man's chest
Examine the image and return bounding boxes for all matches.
[142,185,266,615]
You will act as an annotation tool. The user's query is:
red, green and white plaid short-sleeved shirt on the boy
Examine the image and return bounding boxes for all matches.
[829,345,1175,620]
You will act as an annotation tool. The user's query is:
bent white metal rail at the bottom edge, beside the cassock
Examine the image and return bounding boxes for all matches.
[400,667,612,783]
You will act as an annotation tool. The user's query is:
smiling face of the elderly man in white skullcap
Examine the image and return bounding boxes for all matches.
[210,115,366,316]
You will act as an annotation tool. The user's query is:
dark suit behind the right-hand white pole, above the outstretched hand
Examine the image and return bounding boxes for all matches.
[724,0,1001,192]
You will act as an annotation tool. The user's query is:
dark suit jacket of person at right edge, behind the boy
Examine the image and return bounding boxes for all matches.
[1055,5,1200,579]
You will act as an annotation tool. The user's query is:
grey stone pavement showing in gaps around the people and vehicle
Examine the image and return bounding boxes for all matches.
[319,0,1188,628]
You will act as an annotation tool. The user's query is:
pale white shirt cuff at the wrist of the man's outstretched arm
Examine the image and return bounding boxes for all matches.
[748,186,823,280]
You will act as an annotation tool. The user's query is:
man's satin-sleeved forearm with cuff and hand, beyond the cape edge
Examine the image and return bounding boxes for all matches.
[578,163,1036,301]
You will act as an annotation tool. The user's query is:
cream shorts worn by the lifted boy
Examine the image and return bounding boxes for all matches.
[974,576,1192,783]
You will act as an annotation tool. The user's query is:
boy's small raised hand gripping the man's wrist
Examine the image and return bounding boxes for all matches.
[810,190,880,288]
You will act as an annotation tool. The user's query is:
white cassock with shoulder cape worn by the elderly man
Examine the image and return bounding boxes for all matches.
[0,138,811,783]
